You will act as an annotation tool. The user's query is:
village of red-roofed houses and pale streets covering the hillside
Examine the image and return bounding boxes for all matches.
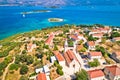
[0,25,120,80]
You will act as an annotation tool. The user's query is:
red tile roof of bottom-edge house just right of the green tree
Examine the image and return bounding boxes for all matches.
[88,70,104,79]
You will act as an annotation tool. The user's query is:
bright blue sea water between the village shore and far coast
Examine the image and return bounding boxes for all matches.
[0,6,120,39]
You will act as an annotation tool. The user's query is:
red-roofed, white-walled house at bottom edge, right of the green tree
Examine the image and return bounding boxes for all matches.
[88,69,105,80]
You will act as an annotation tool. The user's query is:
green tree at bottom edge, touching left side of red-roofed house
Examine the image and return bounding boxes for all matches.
[76,69,88,80]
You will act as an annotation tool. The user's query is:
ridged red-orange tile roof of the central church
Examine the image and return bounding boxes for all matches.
[64,50,77,64]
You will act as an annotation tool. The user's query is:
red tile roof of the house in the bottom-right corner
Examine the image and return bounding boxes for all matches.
[105,65,120,76]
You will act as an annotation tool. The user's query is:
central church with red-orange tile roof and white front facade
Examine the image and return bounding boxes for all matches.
[64,50,78,67]
